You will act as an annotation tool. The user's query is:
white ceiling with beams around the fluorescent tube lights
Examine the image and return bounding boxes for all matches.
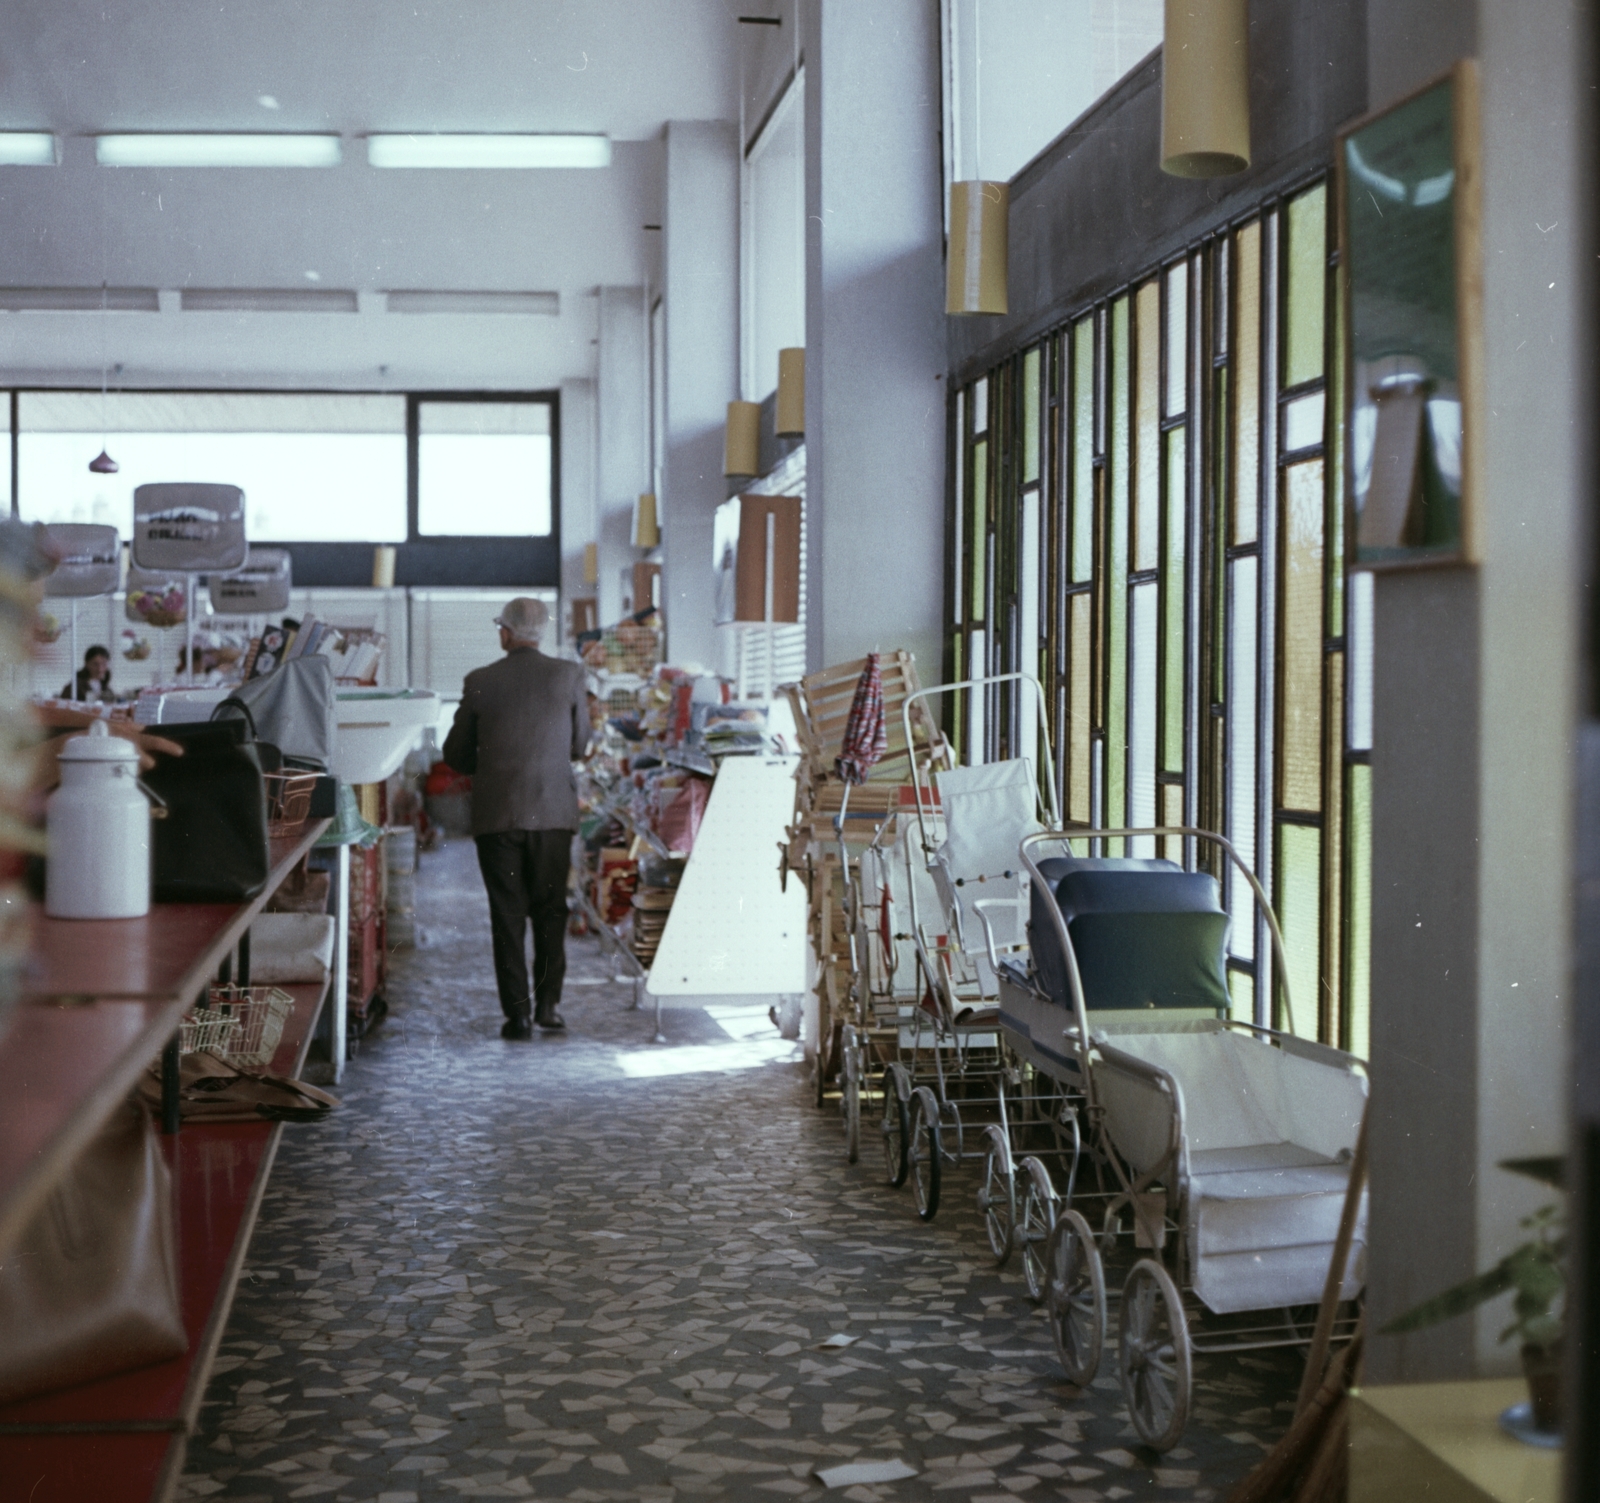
[0,0,752,389]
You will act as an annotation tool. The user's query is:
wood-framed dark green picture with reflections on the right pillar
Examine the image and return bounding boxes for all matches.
[1338,59,1483,570]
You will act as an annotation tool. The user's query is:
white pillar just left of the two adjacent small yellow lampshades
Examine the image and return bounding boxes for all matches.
[661,120,739,667]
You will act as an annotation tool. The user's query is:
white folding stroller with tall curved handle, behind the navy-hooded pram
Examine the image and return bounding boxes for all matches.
[882,672,1061,1229]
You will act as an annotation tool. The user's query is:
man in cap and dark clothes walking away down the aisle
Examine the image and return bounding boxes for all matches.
[445,595,589,1039]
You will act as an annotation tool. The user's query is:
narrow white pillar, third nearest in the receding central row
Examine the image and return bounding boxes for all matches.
[595,287,650,623]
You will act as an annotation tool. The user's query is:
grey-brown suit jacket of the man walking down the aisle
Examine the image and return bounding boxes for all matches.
[445,647,589,836]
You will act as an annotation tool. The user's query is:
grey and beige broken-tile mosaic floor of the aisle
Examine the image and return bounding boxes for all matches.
[181,842,1296,1503]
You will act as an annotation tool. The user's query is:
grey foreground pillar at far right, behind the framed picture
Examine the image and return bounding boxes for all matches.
[1366,0,1586,1383]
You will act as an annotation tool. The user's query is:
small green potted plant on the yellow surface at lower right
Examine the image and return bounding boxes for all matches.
[1382,1205,1566,1434]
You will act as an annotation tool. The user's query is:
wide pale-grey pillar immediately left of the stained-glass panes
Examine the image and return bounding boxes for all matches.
[802,0,946,683]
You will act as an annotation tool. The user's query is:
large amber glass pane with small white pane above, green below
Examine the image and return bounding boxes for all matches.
[1278,459,1323,812]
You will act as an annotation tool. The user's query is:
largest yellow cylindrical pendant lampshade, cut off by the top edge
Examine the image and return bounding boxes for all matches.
[1162,0,1250,178]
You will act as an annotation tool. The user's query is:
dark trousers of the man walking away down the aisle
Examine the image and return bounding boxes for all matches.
[477,829,573,1021]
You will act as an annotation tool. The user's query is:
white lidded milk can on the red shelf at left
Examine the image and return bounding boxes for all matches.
[45,720,150,919]
